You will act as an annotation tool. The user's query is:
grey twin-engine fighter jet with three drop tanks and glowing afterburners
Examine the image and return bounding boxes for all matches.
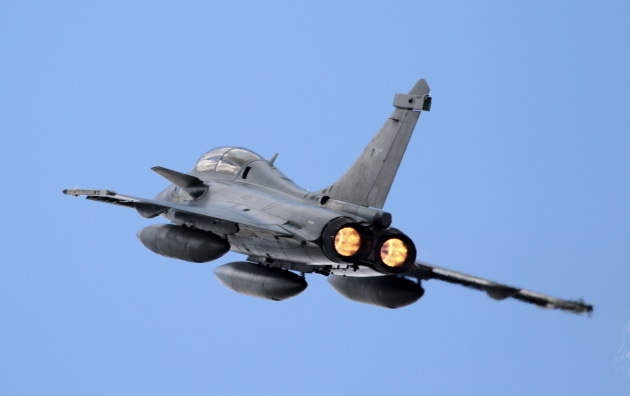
[63,79,593,314]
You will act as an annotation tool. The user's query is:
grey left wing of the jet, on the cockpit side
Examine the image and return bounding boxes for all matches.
[63,188,290,236]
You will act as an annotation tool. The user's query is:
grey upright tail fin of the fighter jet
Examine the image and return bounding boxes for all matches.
[321,79,431,208]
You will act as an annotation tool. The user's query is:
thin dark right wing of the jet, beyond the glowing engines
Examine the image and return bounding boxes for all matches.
[405,263,593,314]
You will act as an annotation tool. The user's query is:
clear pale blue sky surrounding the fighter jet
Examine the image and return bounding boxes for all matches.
[0,1,630,395]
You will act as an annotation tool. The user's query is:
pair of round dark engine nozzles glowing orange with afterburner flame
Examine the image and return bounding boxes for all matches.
[322,217,416,274]
